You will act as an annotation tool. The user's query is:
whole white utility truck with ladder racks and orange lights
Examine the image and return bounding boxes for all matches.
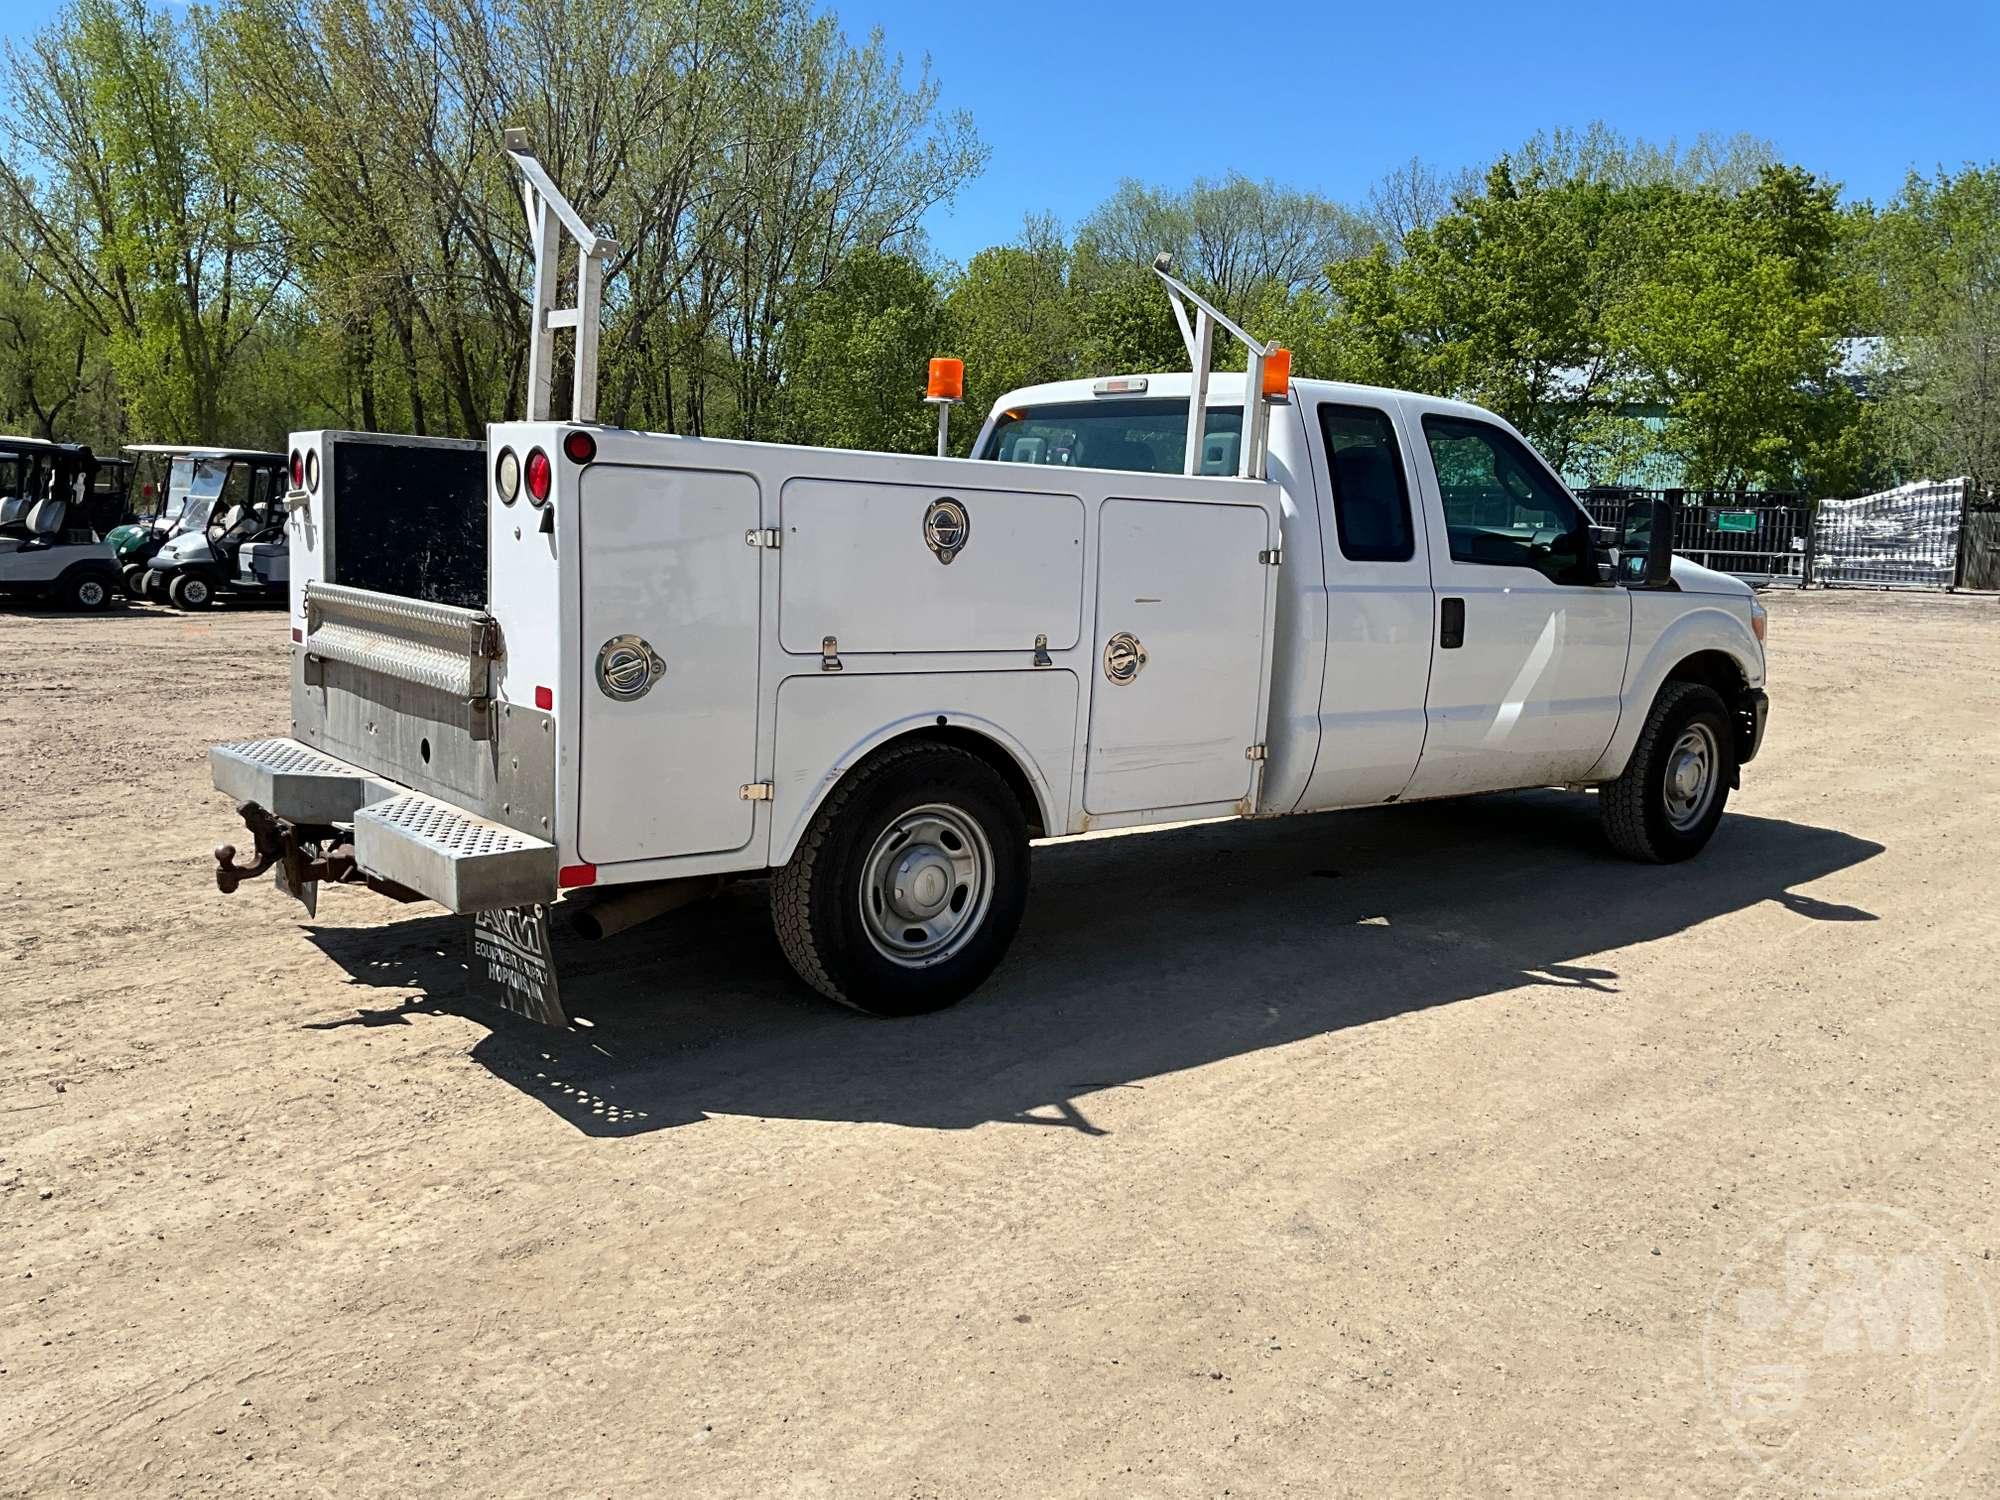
[212,146,1766,1020]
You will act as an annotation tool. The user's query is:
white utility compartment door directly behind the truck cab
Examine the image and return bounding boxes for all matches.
[1084,500,1278,814]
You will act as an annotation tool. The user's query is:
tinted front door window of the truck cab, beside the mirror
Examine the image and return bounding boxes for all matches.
[1424,416,1596,584]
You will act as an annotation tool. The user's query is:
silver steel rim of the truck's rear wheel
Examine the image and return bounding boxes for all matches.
[858,802,994,968]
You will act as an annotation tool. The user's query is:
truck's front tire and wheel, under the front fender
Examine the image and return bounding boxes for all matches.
[1598,682,1736,864]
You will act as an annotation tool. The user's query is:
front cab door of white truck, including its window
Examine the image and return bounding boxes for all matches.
[1408,408,1632,798]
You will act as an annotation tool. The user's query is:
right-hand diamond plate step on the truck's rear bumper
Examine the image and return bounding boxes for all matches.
[354,792,556,912]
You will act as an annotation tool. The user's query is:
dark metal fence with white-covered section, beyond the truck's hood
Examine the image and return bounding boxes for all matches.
[1576,480,2000,590]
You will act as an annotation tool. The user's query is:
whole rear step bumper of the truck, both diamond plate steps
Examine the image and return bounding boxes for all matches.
[208,740,556,914]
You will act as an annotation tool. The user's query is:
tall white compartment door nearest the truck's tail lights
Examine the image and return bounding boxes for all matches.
[584,464,764,864]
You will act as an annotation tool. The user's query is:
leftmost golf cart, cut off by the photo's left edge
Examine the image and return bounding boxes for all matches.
[0,438,124,610]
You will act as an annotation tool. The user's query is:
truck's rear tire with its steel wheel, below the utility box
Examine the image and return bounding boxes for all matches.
[770,742,1028,1016]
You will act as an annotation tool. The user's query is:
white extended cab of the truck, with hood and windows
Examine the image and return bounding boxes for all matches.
[972,372,1764,828]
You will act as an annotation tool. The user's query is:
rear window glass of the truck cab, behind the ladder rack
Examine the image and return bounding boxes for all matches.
[980,398,1244,474]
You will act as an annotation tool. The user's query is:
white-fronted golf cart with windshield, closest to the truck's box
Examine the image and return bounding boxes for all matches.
[140,452,290,610]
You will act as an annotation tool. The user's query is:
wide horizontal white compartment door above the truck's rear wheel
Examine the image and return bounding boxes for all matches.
[778,478,1084,656]
